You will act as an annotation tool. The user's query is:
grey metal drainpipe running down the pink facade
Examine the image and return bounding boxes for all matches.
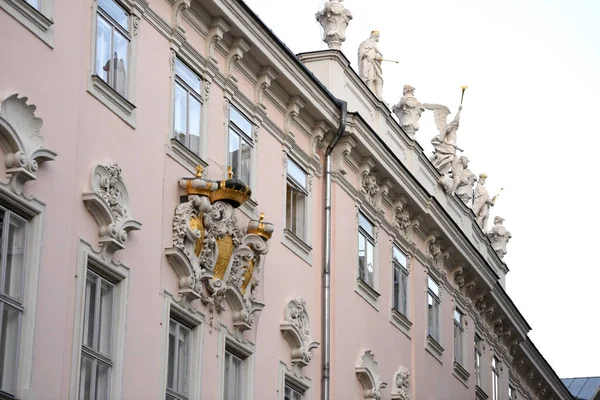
[321,99,348,400]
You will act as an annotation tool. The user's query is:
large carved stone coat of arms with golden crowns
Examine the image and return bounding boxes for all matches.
[165,167,274,331]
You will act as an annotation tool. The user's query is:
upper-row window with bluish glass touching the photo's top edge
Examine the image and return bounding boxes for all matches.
[95,0,131,98]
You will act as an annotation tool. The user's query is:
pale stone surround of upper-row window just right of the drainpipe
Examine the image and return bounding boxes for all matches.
[354,205,381,311]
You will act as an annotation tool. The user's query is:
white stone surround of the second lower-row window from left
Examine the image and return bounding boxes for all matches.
[70,239,129,400]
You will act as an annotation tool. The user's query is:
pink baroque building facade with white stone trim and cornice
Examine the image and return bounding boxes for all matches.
[0,0,571,400]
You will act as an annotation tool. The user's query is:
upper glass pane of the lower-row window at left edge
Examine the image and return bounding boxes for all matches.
[3,213,27,300]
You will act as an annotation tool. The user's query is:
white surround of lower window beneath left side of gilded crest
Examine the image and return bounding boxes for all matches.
[160,291,205,399]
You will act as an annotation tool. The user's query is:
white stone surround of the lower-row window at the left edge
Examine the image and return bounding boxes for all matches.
[0,184,46,398]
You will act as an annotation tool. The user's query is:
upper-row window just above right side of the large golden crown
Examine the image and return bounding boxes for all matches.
[227,106,253,185]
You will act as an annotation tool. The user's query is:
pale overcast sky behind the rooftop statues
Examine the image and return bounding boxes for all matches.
[246,0,600,377]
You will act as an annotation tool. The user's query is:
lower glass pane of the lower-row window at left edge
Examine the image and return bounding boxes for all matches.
[0,303,21,393]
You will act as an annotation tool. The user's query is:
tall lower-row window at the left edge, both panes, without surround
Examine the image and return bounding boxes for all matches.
[0,207,27,395]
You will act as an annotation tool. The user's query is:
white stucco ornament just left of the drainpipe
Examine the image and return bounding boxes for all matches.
[280,297,319,368]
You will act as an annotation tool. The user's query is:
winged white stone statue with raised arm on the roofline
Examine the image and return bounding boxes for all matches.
[423,104,463,175]
